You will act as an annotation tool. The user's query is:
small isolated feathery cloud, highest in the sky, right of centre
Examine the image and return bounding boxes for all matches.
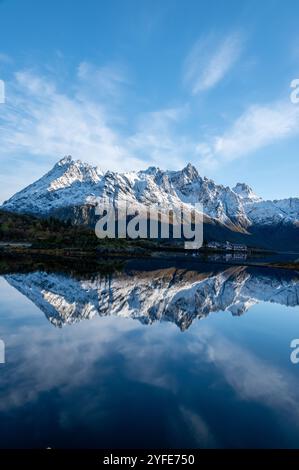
[184,33,243,95]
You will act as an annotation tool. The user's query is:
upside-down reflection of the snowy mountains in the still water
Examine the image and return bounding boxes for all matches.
[5,267,299,331]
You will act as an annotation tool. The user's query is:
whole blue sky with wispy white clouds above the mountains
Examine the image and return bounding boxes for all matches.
[0,0,299,201]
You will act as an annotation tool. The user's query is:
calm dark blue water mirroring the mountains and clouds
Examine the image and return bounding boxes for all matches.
[0,263,299,448]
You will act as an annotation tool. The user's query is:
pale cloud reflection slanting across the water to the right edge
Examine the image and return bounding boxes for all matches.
[190,326,299,423]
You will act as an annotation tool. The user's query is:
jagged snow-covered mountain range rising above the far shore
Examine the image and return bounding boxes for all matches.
[1,157,299,249]
